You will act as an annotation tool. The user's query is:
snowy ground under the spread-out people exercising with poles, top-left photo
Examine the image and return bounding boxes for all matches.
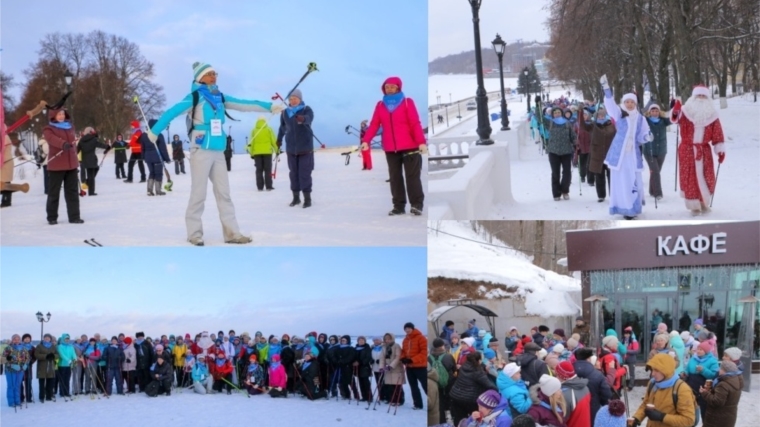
[0,148,427,246]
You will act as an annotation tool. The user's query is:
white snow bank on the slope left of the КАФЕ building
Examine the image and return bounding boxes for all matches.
[428,221,581,317]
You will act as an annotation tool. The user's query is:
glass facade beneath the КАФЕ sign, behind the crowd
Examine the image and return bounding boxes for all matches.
[589,264,760,360]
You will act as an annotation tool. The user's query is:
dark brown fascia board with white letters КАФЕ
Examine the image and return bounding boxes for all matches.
[566,221,760,271]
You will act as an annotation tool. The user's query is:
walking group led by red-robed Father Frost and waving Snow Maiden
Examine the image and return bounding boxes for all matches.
[529,81,726,219]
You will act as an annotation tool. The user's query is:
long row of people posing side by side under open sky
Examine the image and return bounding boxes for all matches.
[1,323,427,409]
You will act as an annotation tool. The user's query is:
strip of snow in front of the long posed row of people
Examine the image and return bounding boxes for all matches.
[0,372,427,427]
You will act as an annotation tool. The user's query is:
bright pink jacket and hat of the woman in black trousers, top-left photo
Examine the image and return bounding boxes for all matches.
[362,77,426,152]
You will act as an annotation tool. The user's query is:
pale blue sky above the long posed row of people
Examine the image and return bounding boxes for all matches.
[0,247,427,339]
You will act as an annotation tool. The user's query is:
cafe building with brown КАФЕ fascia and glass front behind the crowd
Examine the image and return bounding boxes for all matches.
[566,221,760,380]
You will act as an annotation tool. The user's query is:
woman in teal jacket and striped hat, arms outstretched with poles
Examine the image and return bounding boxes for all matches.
[148,62,283,246]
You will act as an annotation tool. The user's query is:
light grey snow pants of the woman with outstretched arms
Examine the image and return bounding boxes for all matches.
[185,147,241,242]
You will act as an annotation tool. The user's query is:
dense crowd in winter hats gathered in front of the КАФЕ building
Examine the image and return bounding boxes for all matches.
[428,317,745,427]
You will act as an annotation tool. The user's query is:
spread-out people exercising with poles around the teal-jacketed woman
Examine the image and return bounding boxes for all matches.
[3,62,427,246]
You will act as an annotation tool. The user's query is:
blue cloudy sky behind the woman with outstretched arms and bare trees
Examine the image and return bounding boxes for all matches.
[0,0,427,152]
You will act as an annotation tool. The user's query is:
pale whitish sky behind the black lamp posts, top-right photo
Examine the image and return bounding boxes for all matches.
[428,0,550,61]
